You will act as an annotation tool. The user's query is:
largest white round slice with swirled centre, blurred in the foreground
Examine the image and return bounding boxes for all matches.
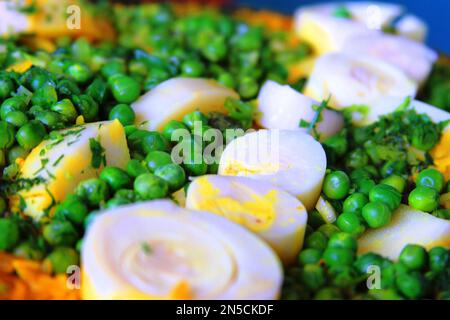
[82,200,282,300]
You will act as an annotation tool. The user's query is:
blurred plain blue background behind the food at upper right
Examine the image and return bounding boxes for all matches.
[237,0,450,54]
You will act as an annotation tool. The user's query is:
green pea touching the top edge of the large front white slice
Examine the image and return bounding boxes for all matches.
[134,173,169,200]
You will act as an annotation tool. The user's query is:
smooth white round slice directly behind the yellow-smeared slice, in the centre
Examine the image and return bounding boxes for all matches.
[218,129,327,210]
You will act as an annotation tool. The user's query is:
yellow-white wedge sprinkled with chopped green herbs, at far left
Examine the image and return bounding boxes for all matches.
[10,120,130,220]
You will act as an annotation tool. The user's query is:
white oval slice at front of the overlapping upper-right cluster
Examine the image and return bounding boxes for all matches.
[304,53,417,109]
